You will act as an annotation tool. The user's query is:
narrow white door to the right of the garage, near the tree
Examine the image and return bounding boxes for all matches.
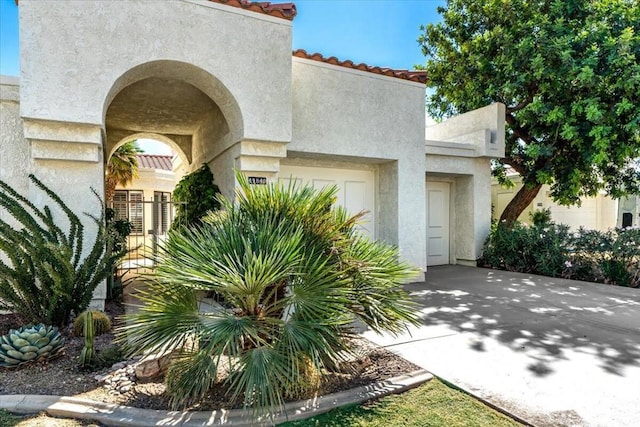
[426,182,451,266]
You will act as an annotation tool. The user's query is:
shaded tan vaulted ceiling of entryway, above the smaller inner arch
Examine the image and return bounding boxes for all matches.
[104,61,244,201]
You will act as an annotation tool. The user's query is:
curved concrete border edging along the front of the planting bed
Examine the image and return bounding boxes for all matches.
[0,370,433,427]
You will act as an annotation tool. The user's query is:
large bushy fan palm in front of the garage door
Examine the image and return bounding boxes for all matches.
[119,174,417,411]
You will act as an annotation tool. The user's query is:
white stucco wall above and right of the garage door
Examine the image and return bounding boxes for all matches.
[287,58,426,268]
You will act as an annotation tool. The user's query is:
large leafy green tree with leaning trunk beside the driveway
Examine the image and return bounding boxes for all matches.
[419,0,640,222]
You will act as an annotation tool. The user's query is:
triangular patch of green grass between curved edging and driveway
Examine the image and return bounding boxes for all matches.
[281,378,522,427]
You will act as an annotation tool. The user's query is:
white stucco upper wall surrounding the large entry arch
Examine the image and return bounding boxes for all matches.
[19,0,291,141]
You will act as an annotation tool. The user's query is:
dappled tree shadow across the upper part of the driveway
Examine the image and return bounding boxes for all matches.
[407,266,640,377]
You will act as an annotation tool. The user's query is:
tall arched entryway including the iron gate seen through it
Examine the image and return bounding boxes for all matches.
[104,61,243,266]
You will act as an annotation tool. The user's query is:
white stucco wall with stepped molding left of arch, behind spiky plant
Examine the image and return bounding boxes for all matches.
[0,76,106,308]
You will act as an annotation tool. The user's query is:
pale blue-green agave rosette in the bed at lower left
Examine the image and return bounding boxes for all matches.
[0,324,64,368]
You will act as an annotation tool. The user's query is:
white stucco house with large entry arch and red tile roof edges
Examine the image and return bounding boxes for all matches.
[0,0,504,304]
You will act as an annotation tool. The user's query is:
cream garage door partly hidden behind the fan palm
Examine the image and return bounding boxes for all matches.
[280,165,375,238]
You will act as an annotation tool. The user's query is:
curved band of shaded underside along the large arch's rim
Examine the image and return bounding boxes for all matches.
[102,60,244,140]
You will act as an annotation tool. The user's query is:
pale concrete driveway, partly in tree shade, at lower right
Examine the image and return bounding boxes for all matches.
[364,266,640,427]
